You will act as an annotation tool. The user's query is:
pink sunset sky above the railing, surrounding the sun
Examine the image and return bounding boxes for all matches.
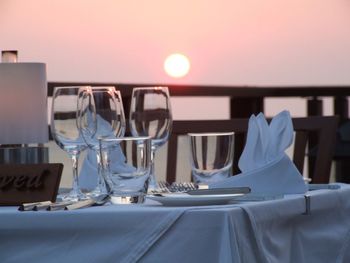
[0,0,350,85]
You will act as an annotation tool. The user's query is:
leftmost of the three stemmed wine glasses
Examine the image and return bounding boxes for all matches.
[50,86,89,201]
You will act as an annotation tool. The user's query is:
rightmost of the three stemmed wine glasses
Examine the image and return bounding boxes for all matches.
[129,87,172,191]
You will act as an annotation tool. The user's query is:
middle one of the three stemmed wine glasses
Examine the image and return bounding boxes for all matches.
[78,87,125,197]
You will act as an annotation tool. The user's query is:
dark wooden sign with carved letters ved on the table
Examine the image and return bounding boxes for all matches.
[0,163,63,205]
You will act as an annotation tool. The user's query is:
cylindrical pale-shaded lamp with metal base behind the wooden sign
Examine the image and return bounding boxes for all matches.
[0,50,48,164]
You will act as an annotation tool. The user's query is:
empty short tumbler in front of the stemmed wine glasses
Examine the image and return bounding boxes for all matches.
[99,137,151,204]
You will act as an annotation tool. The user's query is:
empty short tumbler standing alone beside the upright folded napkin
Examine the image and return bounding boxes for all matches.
[188,132,234,184]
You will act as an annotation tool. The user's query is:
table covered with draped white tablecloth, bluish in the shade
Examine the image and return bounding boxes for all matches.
[0,184,350,263]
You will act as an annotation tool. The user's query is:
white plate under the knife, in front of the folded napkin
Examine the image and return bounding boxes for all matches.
[147,193,244,206]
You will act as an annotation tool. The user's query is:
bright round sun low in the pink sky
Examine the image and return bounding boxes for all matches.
[164,53,191,78]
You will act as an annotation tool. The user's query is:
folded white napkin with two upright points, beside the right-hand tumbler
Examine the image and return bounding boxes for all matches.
[209,111,307,195]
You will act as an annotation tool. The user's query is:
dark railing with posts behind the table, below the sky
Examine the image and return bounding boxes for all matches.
[48,82,350,182]
